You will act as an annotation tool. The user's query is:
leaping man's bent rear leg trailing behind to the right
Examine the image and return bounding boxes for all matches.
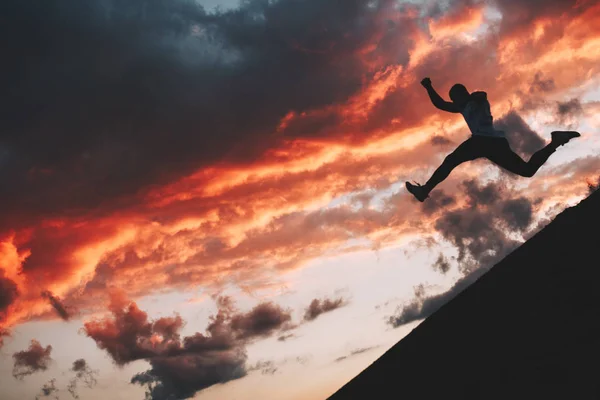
[486,131,580,178]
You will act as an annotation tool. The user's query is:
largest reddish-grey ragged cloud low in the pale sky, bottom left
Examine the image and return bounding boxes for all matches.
[84,294,291,400]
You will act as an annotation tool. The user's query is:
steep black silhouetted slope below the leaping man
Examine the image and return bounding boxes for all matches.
[328,191,600,400]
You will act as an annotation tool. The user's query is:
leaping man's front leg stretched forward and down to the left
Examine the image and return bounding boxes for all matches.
[406,138,483,202]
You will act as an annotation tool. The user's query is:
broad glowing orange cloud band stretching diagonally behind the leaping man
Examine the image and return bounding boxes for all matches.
[0,0,600,334]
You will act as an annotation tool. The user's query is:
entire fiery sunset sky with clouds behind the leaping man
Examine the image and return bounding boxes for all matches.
[0,0,600,400]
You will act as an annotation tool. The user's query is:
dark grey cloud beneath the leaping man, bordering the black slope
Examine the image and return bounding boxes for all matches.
[387,180,533,327]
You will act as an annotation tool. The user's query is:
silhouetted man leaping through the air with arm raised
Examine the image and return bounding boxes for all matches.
[406,78,581,202]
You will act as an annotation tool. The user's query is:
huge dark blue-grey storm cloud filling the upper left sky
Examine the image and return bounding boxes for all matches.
[0,0,420,228]
